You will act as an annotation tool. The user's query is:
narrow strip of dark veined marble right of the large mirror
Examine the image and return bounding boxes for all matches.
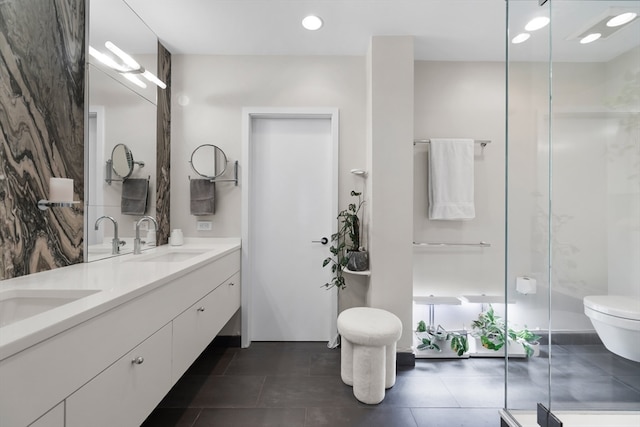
[156,43,171,245]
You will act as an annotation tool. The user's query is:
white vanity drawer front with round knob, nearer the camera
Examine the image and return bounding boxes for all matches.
[66,324,171,427]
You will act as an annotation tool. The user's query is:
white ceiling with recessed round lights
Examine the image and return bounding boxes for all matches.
[121,0,640,61]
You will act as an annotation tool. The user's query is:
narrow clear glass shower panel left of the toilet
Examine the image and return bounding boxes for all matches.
[505,0,551,414]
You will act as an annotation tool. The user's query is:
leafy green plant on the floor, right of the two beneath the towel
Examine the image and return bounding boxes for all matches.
[471,304,540,357]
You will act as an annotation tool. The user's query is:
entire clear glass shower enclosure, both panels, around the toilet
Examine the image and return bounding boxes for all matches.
[503,0,640,427]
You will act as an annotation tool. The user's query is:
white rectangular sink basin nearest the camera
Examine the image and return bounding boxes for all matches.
[0,289,100,328]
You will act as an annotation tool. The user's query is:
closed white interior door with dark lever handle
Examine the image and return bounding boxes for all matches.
[243,110,337,341]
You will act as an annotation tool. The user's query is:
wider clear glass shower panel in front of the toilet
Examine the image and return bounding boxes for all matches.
[549,0,640,418]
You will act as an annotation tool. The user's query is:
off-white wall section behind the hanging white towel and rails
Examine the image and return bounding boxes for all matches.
[413,61,505,296]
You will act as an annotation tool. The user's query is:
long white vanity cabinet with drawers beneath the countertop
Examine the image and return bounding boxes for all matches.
[0,247,240,427]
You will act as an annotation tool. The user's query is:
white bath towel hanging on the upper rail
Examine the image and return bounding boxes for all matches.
[428,139,476,220]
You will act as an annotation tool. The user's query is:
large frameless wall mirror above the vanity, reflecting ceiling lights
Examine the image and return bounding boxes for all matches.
[85,0,158,262]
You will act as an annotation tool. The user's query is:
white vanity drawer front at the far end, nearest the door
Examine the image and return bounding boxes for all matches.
[171,272,240,384]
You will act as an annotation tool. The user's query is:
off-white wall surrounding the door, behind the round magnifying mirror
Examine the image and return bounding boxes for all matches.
[171,55,365,237]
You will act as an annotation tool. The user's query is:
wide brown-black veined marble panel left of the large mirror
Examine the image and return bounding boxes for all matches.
[0,0,85,280]
